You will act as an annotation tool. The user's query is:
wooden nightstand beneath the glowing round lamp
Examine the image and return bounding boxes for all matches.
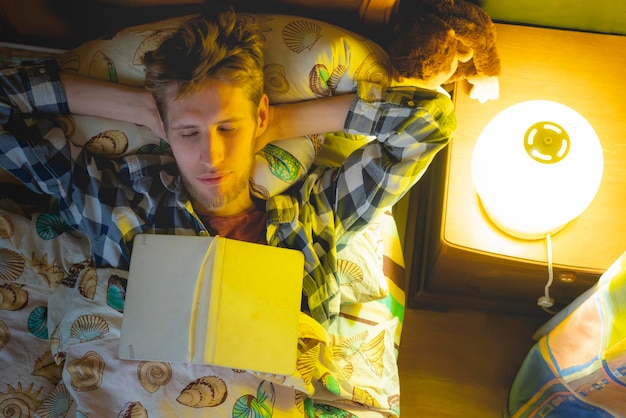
[405,24,626,312]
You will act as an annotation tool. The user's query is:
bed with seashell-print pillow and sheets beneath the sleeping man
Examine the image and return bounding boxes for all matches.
[0,14,405,417]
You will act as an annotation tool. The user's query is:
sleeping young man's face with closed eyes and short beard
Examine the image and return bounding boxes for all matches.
[167,80,269,216]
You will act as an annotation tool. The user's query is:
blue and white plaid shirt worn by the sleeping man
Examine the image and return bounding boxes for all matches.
[0,60,456,325]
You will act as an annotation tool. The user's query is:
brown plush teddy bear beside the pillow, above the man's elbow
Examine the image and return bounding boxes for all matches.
[385,0,501,103]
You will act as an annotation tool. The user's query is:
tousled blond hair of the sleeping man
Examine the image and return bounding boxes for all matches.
[143,7,263,123]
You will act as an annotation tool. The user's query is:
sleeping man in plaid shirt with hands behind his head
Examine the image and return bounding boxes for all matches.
[0,4,456,325]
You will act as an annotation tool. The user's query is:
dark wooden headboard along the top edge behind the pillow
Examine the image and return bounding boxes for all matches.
[0,0,400,49]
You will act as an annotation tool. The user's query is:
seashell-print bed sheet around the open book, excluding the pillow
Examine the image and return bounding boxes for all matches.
[0,191,404,417]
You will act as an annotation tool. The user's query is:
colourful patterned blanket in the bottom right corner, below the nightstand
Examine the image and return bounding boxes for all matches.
[504,253,626,418]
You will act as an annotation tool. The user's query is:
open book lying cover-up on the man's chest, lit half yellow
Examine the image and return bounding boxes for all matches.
[118,234,304,375]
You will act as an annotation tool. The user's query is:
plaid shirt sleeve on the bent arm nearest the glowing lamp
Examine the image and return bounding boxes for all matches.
[330,83,456,233]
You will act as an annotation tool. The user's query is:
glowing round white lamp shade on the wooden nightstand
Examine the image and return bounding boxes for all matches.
[471,100,604,239]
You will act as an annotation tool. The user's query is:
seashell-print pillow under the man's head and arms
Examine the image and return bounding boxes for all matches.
[58,14,389,199]
